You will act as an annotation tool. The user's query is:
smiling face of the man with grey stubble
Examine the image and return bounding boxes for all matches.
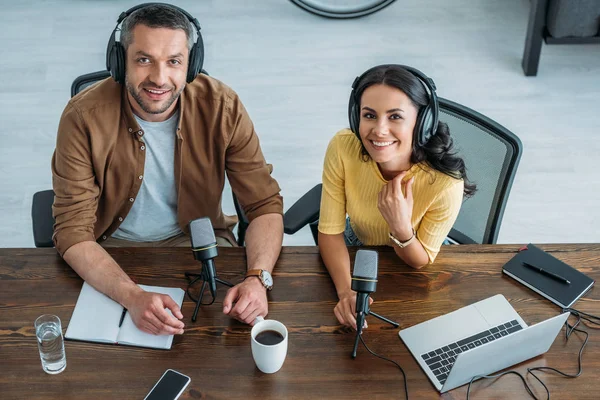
[125,25,189,122]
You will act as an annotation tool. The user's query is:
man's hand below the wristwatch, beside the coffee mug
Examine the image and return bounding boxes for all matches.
[223,277,269,326]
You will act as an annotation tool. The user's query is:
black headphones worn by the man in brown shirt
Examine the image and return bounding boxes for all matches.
[106,3,204,84]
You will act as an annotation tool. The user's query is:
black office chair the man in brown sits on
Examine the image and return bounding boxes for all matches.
[31,70,253,247]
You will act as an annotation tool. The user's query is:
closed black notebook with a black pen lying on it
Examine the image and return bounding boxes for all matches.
[502,243,594,308]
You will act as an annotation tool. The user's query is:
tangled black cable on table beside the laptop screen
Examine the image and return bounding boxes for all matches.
[467,308,600,400]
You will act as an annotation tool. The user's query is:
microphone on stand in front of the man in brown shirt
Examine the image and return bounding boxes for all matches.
[190,217,218,299]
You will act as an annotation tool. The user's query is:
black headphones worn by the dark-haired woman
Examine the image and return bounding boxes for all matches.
[348,64,440,146]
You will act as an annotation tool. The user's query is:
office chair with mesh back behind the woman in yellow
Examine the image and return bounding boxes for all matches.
[283,98,523,244]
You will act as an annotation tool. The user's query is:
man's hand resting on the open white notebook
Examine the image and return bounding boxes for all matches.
[125,290,184,335]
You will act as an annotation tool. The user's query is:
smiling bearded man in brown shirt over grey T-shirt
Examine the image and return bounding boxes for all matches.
[52,5,283,334]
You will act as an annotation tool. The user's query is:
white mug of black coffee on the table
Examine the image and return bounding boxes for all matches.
[250,316,288,374]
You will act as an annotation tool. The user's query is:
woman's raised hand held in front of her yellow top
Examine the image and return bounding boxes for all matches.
[377,171,414,241]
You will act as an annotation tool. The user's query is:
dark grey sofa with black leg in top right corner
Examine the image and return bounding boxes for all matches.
[522,0,600,76]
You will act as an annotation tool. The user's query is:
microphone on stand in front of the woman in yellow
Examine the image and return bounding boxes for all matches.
[351,250,379,335]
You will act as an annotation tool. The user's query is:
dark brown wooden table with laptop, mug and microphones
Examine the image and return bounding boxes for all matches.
[0,244,600,400]
